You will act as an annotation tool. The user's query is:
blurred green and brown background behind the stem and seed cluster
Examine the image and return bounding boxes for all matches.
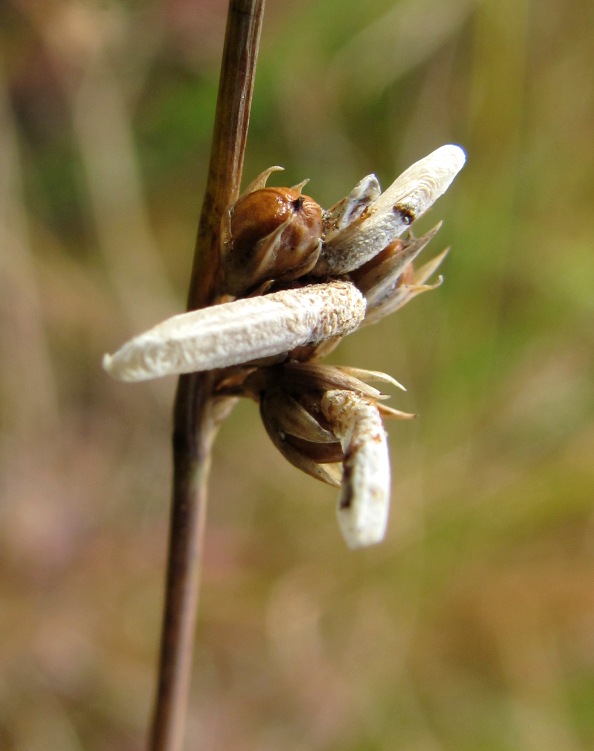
[0,0,594,751]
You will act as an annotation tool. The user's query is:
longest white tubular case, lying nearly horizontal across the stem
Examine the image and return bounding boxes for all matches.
[103,281,365,381]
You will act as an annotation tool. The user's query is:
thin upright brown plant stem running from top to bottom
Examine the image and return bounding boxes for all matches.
[149,0,265,751]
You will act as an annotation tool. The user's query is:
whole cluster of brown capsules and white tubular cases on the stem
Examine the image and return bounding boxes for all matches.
[103,145,465,548]
